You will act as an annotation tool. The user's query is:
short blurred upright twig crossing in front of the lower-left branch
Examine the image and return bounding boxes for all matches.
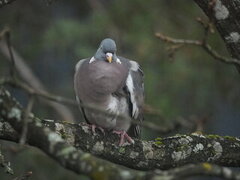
[19,95,35,145]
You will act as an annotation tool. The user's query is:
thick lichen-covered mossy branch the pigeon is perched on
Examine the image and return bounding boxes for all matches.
[43,122,240,170]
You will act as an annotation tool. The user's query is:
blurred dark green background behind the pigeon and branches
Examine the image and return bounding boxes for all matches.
[0,0,240,180]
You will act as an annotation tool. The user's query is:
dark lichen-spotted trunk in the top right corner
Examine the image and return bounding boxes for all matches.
[194,0,240,72]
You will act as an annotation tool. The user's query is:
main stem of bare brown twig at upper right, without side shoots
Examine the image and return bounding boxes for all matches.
[155,32,240,65]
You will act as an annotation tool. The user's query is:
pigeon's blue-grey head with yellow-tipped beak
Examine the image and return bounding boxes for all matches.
[94,38,118,63]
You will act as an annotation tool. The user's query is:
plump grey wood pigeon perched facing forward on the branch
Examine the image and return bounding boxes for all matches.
[74,38,144,145]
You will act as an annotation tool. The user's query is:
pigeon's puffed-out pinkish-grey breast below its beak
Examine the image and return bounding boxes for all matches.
[75,61,128,105]
